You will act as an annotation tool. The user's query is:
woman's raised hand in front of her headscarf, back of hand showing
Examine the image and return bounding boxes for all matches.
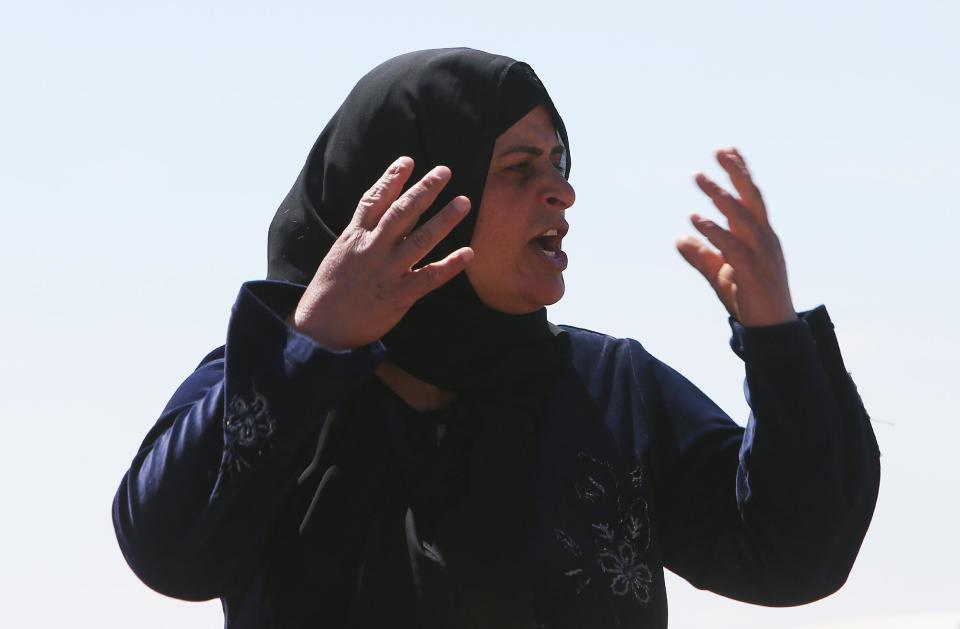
[290,157,473,350]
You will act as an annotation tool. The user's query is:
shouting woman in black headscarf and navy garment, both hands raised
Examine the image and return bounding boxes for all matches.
[114,49,879,628]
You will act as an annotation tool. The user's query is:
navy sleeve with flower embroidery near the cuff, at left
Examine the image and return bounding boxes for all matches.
[113,281,384,600]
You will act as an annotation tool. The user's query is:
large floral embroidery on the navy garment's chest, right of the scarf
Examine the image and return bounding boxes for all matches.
[554,453,653,604]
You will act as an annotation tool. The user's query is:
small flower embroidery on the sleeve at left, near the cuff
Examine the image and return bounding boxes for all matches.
[223,391,276,475]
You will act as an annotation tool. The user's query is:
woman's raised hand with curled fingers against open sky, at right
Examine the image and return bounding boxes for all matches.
[677,148,797,326]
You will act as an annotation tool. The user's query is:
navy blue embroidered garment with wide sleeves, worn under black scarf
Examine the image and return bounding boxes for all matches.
[113,281,879,629]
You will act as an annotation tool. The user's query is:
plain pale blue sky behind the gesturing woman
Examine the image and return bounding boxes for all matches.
[0,0,960,629]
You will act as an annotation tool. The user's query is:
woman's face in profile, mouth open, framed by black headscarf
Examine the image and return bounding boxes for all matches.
[466,105,576,314]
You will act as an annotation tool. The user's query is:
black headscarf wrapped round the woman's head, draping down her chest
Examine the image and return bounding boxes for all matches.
[268,48,570,628]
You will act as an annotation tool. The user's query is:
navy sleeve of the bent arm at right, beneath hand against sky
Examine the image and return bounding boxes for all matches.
[651,306,880,606]
